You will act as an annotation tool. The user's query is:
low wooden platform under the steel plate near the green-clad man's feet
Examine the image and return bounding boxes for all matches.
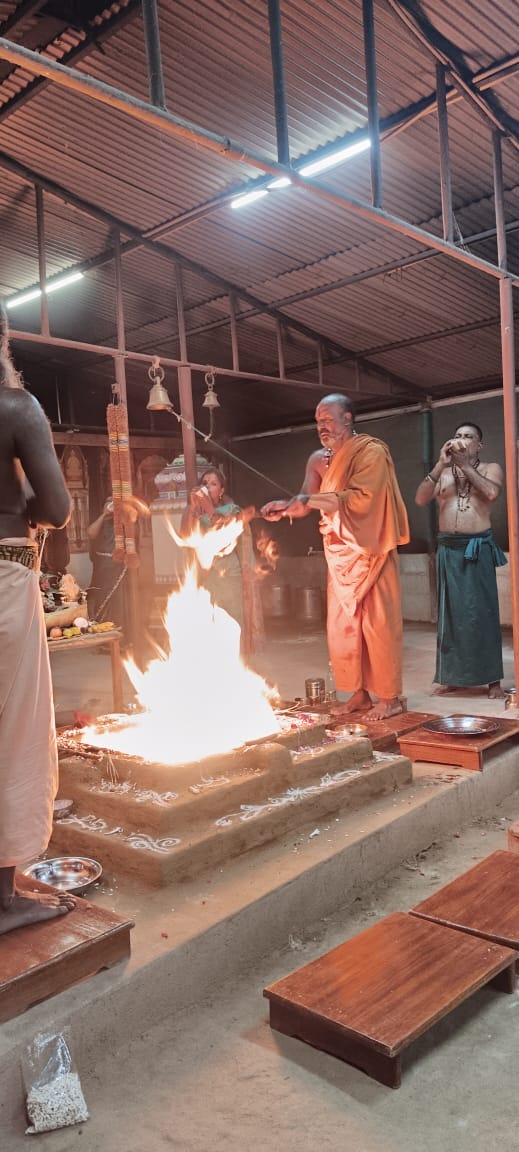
[398,713,519,772]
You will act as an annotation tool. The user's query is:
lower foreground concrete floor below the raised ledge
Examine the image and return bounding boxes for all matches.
[0,794,519,1152]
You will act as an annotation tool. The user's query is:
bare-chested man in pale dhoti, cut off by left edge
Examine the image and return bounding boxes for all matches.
[0,308,75,934]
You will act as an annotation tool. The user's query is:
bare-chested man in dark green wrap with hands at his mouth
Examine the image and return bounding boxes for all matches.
[415,423,506,699]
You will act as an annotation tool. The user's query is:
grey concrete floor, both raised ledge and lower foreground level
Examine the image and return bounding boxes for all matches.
[0,626,519,1152]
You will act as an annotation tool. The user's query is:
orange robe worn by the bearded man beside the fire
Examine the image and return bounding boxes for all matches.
[320,434,409,700]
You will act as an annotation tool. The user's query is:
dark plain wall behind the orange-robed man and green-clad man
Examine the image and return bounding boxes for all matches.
[230,396,507,556]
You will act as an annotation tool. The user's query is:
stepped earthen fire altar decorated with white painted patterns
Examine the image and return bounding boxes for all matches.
[48,713,411,887]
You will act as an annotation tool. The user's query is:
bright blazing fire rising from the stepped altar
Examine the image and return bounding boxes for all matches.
[82,520,278,764]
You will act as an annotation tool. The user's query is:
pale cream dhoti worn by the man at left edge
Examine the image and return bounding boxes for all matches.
[0,540,58,867]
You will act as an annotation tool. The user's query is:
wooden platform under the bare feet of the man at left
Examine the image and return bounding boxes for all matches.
[0,873,133,1023]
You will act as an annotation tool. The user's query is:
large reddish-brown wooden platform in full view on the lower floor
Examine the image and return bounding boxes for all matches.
[264,912,516,1087]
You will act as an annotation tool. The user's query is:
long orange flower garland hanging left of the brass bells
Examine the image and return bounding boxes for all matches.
[106,389,139,568]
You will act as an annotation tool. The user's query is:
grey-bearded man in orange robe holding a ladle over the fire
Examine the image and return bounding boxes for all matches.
[261,394,410,720]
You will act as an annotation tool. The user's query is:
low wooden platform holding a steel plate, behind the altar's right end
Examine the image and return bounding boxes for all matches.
[398,713,519,772]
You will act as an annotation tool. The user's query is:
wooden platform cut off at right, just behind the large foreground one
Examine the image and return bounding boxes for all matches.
[411,851,519,950]
